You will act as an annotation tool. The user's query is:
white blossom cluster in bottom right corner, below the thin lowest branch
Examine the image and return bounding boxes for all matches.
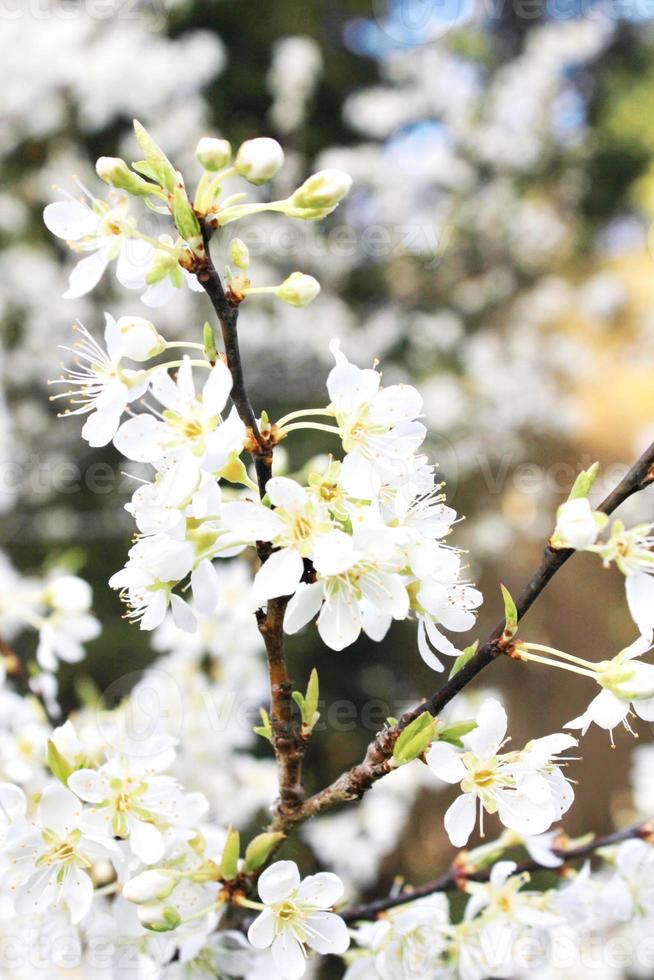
[345,840,654,980]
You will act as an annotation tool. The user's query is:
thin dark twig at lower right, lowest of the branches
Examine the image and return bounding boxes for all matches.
[339,823,654,922]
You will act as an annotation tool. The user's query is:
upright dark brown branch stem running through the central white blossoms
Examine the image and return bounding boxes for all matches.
[196,221,306,820]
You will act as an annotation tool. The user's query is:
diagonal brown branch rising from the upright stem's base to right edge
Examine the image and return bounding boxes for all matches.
[295,443,654,822]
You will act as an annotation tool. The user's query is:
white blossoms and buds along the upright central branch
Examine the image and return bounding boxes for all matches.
[45,124,481,670]
